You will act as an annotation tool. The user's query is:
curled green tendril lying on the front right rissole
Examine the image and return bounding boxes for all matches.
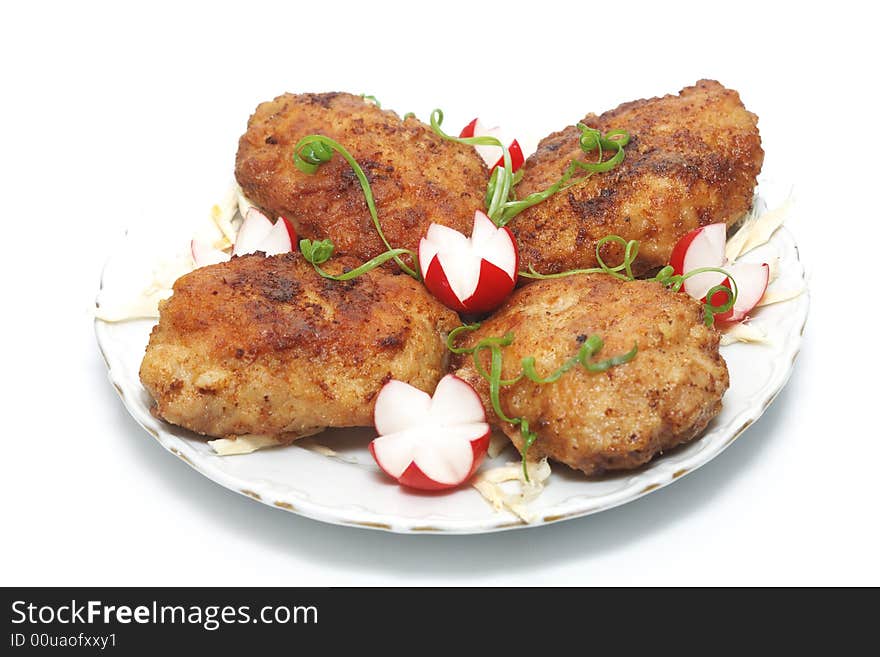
[446,323,638,481]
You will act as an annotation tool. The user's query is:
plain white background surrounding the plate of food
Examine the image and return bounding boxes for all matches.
[0,0,880,585]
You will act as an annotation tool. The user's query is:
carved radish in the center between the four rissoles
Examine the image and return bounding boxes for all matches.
[419,210,519,314]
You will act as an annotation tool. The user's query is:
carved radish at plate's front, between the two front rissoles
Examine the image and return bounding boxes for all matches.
[370,374,490,490]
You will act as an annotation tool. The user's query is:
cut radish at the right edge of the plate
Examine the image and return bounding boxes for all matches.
[669,223,770,324]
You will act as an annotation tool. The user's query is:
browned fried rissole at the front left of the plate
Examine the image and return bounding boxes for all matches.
[140,253,459,440]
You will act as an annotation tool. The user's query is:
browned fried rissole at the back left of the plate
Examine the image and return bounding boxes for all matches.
[235,93,489,260]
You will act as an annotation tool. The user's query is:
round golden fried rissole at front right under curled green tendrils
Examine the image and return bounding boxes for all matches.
[455,274,729,475]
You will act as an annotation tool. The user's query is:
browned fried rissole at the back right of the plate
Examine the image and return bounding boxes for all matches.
[510,80,764,275]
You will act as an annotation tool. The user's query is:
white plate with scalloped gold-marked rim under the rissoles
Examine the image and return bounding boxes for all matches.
[95,185,809,533]
